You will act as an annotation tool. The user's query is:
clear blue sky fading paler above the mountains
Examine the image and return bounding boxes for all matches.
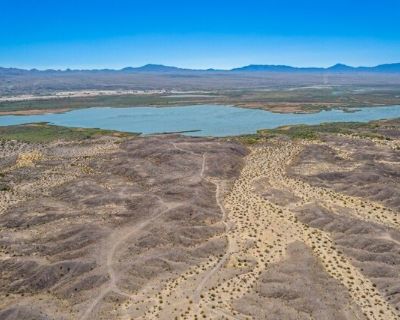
[0,0,400,69]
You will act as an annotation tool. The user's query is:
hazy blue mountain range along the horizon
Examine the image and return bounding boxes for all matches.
[0,63,400,76]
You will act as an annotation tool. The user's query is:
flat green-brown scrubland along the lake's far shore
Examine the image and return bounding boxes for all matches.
[0,85,400,112]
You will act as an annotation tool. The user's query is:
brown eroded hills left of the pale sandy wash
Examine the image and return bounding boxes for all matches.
[0,136,247,320]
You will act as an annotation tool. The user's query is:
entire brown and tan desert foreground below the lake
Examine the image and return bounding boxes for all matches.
[0,125,400,320]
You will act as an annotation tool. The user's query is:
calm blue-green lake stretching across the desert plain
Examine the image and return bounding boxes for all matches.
[0,105,400,137]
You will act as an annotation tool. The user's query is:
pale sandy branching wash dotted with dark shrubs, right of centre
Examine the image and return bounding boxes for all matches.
[187,143,397,320]
